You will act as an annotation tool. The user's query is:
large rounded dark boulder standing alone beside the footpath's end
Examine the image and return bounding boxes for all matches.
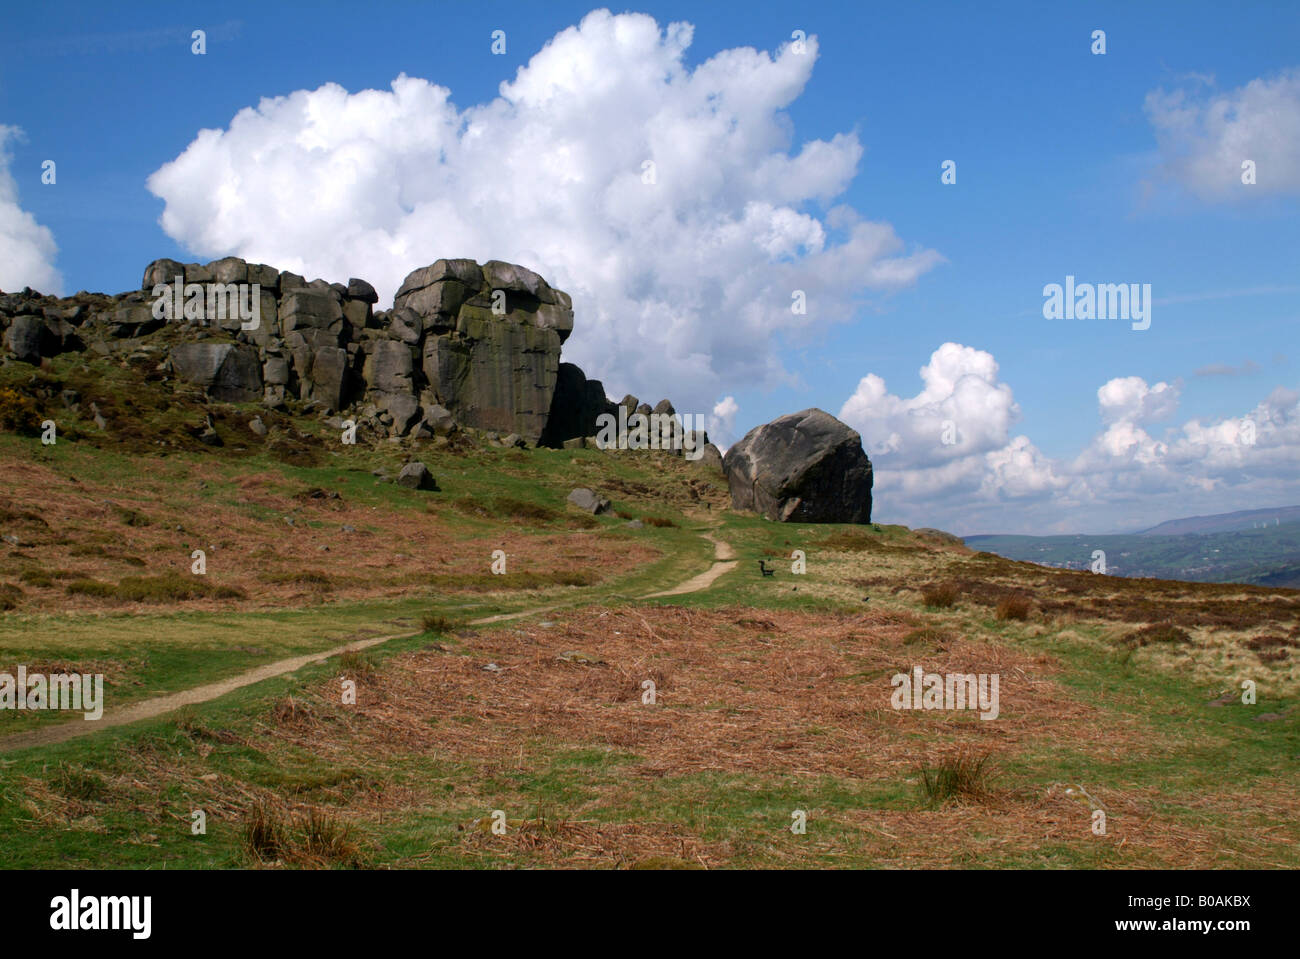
[723,409,872,522]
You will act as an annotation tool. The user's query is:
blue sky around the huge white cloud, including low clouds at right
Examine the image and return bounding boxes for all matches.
[0,3,1300,533]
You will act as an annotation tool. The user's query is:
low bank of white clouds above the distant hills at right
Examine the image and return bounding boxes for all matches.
[840,343,1300,534]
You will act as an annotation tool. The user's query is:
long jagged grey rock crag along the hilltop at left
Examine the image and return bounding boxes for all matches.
[0,256,719,467]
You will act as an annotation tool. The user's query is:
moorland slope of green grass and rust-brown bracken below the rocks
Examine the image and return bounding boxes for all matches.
[0,361,1300,868]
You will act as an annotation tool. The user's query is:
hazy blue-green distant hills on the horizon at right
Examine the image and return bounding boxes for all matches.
[963,507,1300,589]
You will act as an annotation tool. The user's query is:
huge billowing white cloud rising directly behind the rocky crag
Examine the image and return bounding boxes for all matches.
[148,10,941,412]
